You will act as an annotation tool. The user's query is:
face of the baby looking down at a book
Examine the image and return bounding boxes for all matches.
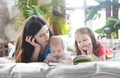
[50,44,64,59]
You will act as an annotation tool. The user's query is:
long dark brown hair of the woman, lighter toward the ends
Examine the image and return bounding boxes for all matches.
[15,15,52,62]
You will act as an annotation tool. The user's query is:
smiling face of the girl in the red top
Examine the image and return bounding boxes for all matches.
[75,33,92,50]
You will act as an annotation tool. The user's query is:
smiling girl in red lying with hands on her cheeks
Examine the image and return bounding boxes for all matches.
[75,27,113,61]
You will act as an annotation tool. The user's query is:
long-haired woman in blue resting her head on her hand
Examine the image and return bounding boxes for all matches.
[14,15,51,63]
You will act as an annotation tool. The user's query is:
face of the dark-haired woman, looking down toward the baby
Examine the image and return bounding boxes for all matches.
[35,25,49,47]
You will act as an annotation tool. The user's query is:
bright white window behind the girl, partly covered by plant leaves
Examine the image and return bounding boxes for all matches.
[66,0,106,36]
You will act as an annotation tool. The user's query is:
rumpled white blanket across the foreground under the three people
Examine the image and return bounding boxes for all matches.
[0,58,120,78]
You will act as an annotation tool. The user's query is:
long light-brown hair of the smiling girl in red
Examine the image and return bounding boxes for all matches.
[75,27,100,56]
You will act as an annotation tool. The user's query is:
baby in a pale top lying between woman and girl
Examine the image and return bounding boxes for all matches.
[44,36,72,64]
